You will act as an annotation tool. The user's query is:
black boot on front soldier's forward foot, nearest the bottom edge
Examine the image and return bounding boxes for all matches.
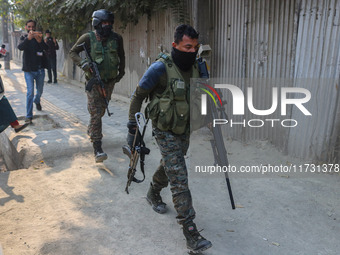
[183,221,212,253]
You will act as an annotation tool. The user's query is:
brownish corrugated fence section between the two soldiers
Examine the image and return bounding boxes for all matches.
[115,7,183,96]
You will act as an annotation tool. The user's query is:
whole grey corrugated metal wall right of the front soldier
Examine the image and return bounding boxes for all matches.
[205,0,340,160]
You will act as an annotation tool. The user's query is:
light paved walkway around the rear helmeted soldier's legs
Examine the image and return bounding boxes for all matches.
[0,62,139,169]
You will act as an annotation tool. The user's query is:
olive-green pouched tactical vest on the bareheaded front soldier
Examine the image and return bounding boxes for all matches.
[145,53,199,135]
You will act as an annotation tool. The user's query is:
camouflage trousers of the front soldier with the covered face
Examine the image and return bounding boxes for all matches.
[152,128,195,224]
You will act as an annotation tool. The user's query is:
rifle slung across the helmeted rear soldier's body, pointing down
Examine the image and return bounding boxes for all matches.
[78,42,112,117]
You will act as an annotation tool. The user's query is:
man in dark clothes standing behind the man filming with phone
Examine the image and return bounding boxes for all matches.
[45,29,59,83]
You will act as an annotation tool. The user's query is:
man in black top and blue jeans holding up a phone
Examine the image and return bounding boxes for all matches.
[18,20,48,123]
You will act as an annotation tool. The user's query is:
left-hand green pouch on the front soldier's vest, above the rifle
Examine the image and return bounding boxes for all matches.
[157,98,174,131]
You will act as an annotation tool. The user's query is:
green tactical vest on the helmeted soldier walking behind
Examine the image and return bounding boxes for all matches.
[89,31,119,82]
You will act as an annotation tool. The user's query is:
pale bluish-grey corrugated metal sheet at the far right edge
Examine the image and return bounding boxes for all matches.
[288,0,340,160]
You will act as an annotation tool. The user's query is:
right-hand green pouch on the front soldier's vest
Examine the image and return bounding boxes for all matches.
[171,101,189,135]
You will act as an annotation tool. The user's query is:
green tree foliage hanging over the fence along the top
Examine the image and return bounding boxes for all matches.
[10,0,186,42]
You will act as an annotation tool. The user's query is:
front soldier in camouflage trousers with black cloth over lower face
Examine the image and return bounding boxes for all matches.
[127,25,212,252]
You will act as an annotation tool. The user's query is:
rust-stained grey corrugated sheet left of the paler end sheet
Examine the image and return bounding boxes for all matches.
[211,0,294,147]
